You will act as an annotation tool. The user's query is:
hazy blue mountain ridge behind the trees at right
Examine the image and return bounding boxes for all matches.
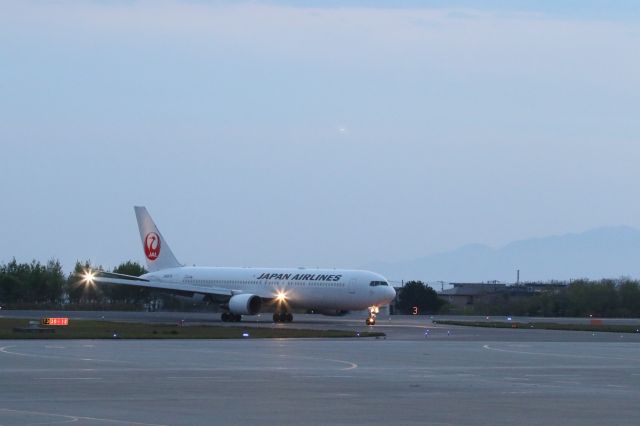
[366,225,640,282]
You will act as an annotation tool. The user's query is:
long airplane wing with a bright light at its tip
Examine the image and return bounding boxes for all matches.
[84,271,233,297]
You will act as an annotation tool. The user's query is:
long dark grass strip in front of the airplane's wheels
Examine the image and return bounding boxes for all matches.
[0,318,385,339]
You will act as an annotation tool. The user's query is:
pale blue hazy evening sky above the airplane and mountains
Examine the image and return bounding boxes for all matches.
[0,0,640,270]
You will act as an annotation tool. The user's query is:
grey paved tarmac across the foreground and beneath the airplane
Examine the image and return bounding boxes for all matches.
[0,311,640,426]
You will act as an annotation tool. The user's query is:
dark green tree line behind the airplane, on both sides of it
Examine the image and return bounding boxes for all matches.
[0,259,640,317]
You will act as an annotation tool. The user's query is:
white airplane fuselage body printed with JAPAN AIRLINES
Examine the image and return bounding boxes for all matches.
[141,266,395,310]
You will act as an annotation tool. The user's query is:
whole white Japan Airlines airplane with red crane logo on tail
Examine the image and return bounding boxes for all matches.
[84,207,396,325]
